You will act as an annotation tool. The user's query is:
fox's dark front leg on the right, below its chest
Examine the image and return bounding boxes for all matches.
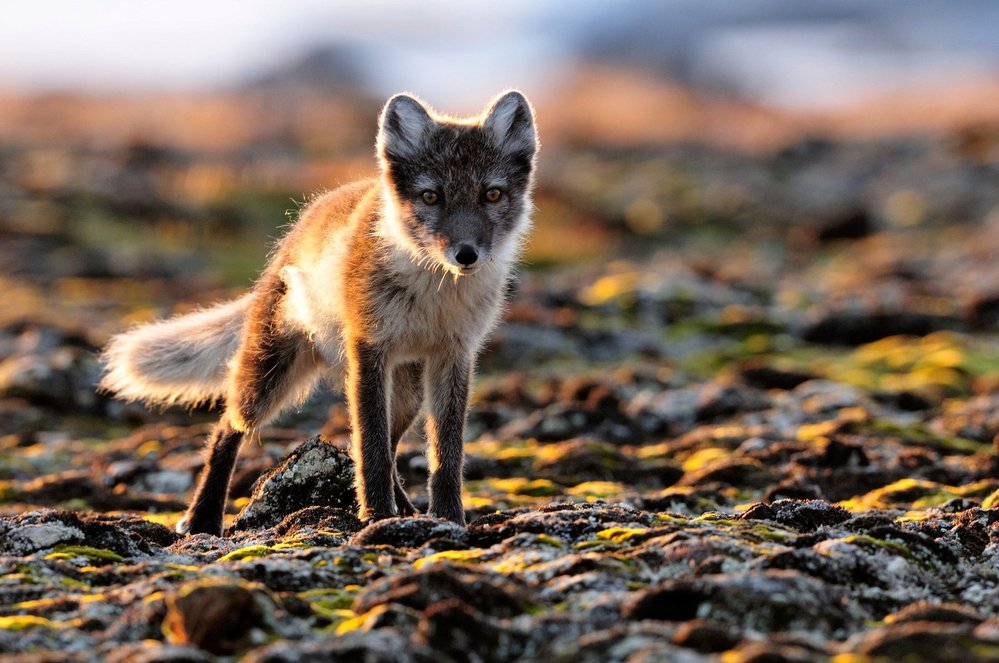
[426,354,472,525]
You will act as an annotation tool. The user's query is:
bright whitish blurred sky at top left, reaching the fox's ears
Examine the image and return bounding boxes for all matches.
[0,0,554,107]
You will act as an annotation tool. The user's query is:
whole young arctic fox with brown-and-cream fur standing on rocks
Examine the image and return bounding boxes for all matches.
[99,90,539,536]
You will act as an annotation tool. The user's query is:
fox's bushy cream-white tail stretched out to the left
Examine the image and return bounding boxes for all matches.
[100,295,250,406]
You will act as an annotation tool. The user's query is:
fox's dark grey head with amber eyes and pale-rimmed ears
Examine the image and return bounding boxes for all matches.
[378,91,538,275]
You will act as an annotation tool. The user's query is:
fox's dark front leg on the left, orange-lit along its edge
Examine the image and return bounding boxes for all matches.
[346,340,396,520]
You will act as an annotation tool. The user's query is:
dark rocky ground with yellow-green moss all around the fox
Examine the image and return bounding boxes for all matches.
[0,116,999,663]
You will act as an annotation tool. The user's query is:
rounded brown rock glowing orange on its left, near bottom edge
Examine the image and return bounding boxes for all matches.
[163,579,274,655]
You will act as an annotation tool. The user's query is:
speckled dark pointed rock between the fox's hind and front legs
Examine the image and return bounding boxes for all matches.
[232,437,357,531]
